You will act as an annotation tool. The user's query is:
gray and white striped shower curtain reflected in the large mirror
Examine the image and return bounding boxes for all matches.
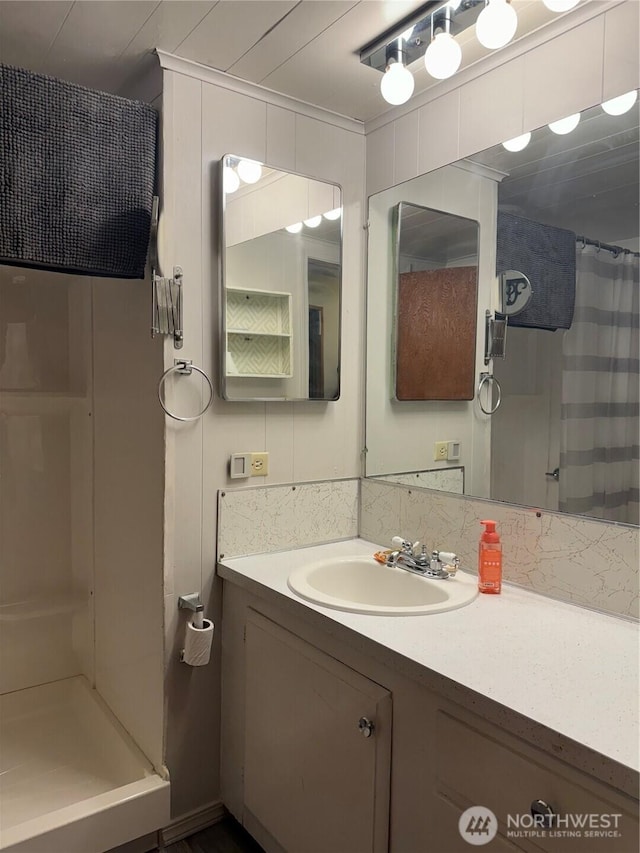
[560,246,640,524]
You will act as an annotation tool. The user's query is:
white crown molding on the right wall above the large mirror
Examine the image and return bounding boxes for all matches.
[364,0,629,135]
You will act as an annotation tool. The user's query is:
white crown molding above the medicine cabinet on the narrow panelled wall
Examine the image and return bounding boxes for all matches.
[156,48,364,136]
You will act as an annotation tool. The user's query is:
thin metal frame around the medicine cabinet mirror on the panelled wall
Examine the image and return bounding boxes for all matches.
[216,152,344,403]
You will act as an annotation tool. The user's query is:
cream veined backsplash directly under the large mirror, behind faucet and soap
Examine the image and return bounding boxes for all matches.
[360,480,639,618]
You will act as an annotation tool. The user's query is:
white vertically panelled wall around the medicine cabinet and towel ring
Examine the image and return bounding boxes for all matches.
[160,55,365,816]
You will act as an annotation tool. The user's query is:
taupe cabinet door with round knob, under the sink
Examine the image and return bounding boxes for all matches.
[244,612,391,853]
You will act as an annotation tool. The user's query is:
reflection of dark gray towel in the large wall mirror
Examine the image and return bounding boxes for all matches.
[496,211,576,330]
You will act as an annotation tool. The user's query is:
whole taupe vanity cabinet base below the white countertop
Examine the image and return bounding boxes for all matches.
[221,572,638,853]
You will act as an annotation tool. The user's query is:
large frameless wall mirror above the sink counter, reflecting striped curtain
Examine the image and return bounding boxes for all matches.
[366,88,640,524]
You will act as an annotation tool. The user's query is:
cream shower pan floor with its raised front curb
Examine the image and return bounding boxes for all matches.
[0,676,169,853]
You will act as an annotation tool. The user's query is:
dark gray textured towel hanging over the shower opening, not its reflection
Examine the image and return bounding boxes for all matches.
[0,64,157,278]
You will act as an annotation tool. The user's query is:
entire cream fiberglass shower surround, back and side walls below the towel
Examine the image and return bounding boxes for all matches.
[0,266,164,767]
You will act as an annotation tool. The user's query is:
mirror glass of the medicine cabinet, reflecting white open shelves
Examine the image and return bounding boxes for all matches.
[220,154,342,400]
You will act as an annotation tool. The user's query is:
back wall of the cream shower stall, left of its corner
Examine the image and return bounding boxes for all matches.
[0,266,93,693]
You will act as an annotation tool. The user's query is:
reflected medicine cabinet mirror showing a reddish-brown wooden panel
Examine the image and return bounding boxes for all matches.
[393,201,479,401]
